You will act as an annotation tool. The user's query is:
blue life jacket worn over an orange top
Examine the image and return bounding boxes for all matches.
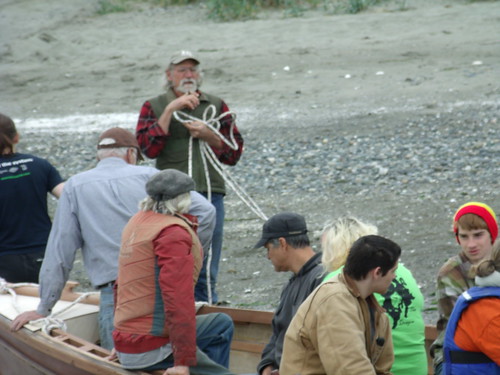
[443,286,500,375]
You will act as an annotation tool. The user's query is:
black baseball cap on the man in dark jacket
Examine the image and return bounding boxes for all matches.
[254,212,307,249]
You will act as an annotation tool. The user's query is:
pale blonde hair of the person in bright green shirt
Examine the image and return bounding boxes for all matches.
[321,216,378,272]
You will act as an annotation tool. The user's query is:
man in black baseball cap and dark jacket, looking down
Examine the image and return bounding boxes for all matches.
[255,212,323,375]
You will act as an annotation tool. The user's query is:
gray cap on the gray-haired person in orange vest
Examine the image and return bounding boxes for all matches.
[146,169,195,201]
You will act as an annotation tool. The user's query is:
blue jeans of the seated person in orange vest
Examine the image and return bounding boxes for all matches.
[143,313,234,375]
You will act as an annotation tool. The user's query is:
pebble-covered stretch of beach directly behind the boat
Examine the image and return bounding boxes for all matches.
[19,103,500,323]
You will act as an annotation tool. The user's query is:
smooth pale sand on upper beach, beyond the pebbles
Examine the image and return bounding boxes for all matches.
[0,0,500,119]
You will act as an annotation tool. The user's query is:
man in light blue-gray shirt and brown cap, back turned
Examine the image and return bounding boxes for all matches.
[12,128,215,349]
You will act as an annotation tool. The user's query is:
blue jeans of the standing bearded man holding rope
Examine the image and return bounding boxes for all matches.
[194,193,225,304]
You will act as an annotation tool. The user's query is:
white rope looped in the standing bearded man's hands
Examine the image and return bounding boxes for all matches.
[173,104,267,304]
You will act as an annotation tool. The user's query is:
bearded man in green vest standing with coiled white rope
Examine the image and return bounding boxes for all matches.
[136,51,243,303]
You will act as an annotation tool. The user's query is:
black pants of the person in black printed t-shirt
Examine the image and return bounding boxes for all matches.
[0,251,45,283]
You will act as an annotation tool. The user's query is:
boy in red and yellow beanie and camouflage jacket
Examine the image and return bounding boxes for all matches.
[431,202,498,375]
